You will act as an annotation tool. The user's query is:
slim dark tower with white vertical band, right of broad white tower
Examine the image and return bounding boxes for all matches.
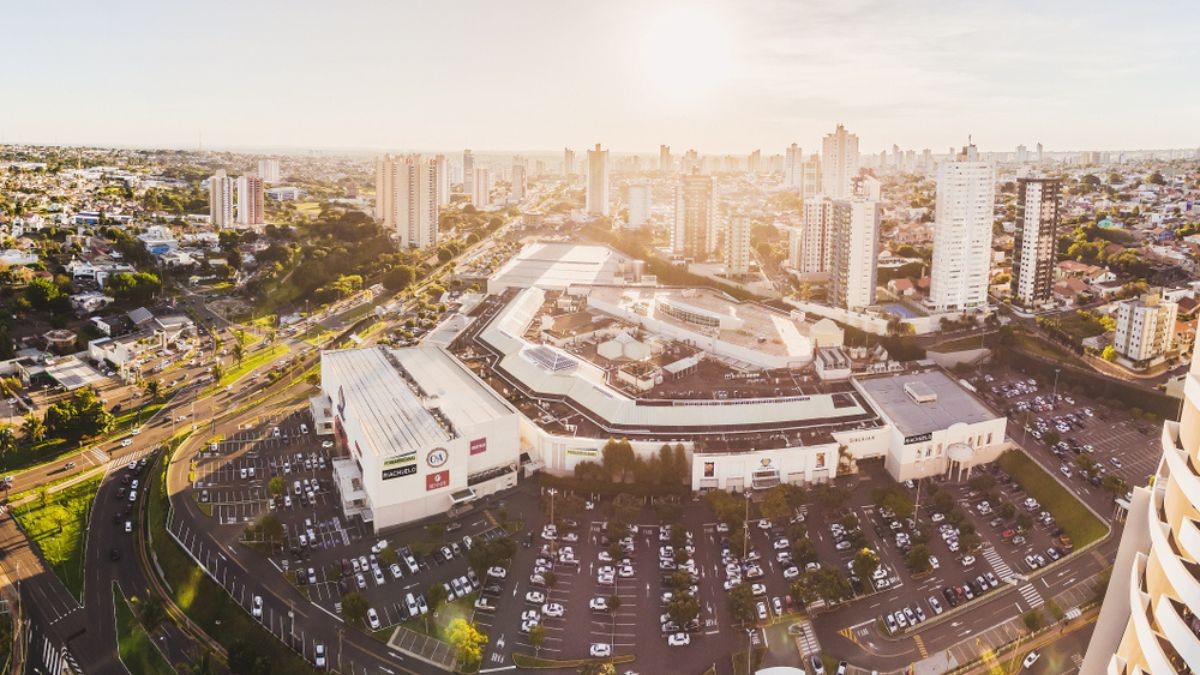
[1012,178,1062,306]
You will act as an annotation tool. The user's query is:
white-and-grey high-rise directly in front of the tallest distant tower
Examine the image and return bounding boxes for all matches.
[829,175,880,310]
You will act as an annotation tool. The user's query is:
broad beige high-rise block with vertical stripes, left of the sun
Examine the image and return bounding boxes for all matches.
[376,155,444,249]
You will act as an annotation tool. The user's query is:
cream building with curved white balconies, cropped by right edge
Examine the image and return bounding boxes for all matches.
[1079,343,1200,675]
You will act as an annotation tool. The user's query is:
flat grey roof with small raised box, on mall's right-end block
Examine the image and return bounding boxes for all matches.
[857,370,1000,436]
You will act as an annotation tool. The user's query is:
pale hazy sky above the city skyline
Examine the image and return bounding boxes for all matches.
[0,0,1200,154]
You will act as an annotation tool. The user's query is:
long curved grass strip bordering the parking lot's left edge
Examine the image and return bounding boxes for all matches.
[146,446,313,673]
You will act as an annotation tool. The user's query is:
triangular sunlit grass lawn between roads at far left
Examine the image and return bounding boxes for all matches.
[12,476,103,597]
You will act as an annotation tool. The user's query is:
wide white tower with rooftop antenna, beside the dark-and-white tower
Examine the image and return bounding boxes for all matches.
[929,142,996,311]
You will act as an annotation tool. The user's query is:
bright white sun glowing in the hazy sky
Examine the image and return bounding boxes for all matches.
[638,6,731,102]
